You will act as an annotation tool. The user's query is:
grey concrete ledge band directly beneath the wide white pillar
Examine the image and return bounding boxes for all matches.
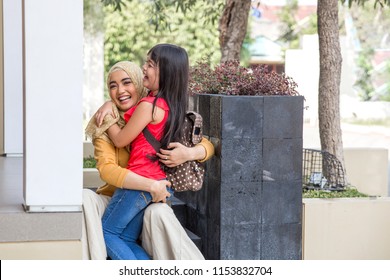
[0,211,82,244]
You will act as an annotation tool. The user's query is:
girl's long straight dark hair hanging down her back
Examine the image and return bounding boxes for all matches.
[148,44,189,147]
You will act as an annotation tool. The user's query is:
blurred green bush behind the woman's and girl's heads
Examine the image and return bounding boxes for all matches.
[104,1,220,74]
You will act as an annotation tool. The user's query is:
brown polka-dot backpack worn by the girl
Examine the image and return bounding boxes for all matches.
[143,111,205,192]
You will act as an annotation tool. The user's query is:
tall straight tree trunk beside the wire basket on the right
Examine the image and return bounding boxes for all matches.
[317,0,345,178]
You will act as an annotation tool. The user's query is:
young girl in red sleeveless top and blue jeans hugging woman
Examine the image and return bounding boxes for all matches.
[98,44,189,259]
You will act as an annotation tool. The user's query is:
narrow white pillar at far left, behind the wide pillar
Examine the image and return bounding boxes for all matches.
[3,0,23,156]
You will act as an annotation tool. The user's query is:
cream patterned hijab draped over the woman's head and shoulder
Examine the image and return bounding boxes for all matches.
[85,61,147,144]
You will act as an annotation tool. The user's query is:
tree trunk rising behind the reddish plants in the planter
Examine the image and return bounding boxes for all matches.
[218,0,251,62]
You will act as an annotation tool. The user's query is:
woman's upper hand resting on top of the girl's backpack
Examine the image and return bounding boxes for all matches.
[157,142,192,167]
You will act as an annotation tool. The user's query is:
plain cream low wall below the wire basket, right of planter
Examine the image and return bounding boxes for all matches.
[302,197,390,260]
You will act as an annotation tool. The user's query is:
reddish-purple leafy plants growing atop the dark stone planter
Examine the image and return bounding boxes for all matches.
[189,61,299,96]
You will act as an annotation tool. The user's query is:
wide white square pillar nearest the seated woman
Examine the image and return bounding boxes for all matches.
[22,0,83,212]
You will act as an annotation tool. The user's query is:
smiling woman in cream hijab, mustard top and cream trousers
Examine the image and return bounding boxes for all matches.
[82,61,214,260]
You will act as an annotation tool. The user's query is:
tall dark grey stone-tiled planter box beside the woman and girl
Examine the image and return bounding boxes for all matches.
[176,94,303,259]
